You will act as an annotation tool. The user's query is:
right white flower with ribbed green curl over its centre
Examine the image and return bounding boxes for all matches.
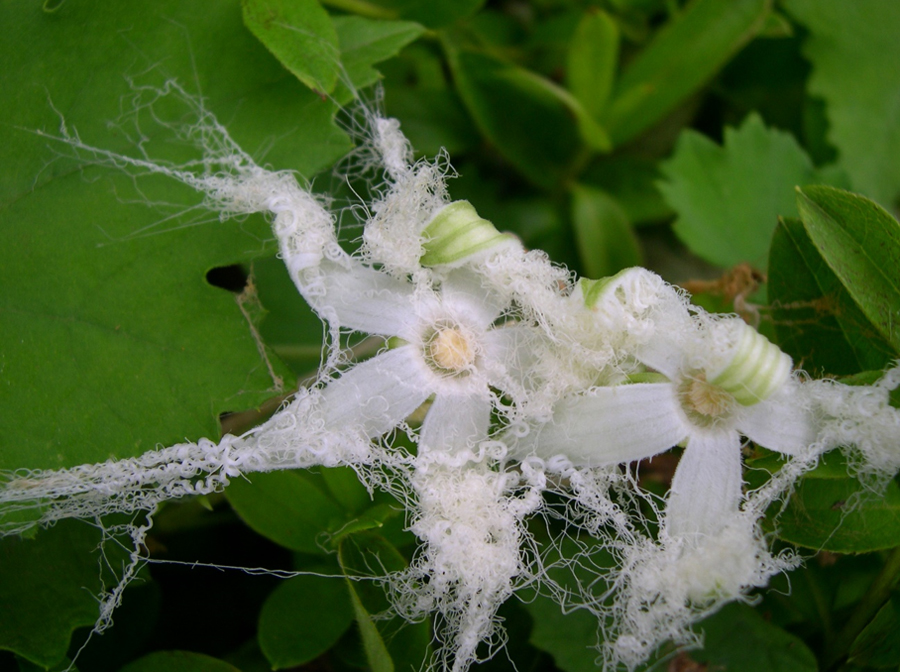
[516,276,816,537]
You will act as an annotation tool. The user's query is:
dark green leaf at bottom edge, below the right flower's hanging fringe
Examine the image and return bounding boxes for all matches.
[691,603,819,672]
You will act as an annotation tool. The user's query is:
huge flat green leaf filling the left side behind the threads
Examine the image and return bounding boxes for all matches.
[0,0,347,469]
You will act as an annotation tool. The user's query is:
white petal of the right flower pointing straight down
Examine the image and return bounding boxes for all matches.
[665,431,742,539]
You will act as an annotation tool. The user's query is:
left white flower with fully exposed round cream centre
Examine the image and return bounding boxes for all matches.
[314,263,527,451]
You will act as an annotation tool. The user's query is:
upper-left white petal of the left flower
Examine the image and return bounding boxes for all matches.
[304,262,417,338]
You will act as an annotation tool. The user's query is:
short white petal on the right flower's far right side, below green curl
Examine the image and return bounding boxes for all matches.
[738,382,819,455]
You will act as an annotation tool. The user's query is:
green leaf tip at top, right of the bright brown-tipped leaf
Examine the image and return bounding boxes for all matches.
[334,16,425,96]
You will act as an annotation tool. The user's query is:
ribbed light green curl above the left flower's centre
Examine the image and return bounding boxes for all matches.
[419,201,515,266]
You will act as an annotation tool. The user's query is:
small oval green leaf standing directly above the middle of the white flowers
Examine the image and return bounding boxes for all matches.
[572,185,641,278]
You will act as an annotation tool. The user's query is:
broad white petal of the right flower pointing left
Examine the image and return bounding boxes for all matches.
[516,383,690,466]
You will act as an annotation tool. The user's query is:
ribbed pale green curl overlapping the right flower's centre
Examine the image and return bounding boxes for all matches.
[709,325,792,406]
